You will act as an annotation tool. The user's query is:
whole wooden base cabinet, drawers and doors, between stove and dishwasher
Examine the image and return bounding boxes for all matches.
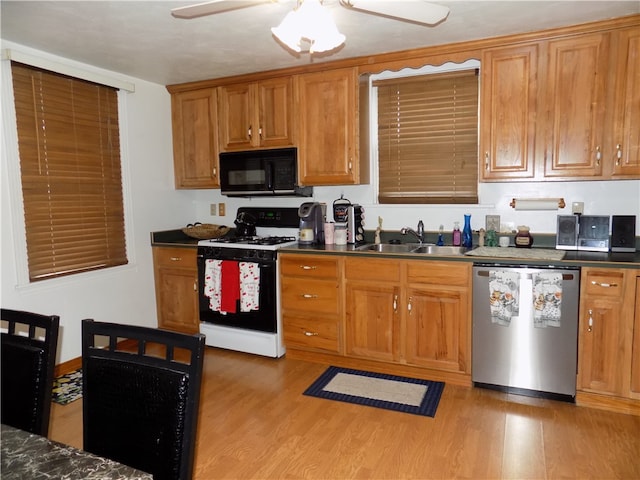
[278,252,471,385]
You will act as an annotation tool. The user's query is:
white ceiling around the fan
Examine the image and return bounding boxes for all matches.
[0,0,640,85]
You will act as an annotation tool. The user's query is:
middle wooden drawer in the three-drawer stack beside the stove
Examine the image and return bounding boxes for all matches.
[281,277,338,314]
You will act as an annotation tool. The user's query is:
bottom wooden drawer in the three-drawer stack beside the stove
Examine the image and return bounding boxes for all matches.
[283,315,338,352]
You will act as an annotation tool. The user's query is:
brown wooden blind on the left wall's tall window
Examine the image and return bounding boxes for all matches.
[12,62,127,281]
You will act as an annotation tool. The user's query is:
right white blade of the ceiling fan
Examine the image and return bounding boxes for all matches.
[340,0,449,25]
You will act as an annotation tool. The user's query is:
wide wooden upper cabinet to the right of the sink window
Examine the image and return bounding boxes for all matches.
[479,23,640,181]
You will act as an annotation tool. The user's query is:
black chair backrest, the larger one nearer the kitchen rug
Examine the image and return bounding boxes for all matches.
[82,319,205,480]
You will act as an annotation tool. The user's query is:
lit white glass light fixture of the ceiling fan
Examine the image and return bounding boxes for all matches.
[271,0,346,53]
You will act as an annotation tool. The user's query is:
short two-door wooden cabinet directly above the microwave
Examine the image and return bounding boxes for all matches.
[218,77,294,151]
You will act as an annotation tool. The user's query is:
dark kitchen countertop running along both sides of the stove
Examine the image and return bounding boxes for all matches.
[151,229,640,268]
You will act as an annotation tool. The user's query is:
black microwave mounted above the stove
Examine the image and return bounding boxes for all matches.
[220,148,313,197]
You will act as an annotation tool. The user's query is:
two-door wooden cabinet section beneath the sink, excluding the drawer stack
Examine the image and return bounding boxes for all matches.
[345,258,471,374]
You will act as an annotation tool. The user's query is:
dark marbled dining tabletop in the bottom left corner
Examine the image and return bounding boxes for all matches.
[0,424,153,480]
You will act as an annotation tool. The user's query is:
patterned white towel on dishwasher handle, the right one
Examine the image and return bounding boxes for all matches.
[533,272,562,328]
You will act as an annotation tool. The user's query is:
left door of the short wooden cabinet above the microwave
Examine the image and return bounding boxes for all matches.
[218,84,252,150]
